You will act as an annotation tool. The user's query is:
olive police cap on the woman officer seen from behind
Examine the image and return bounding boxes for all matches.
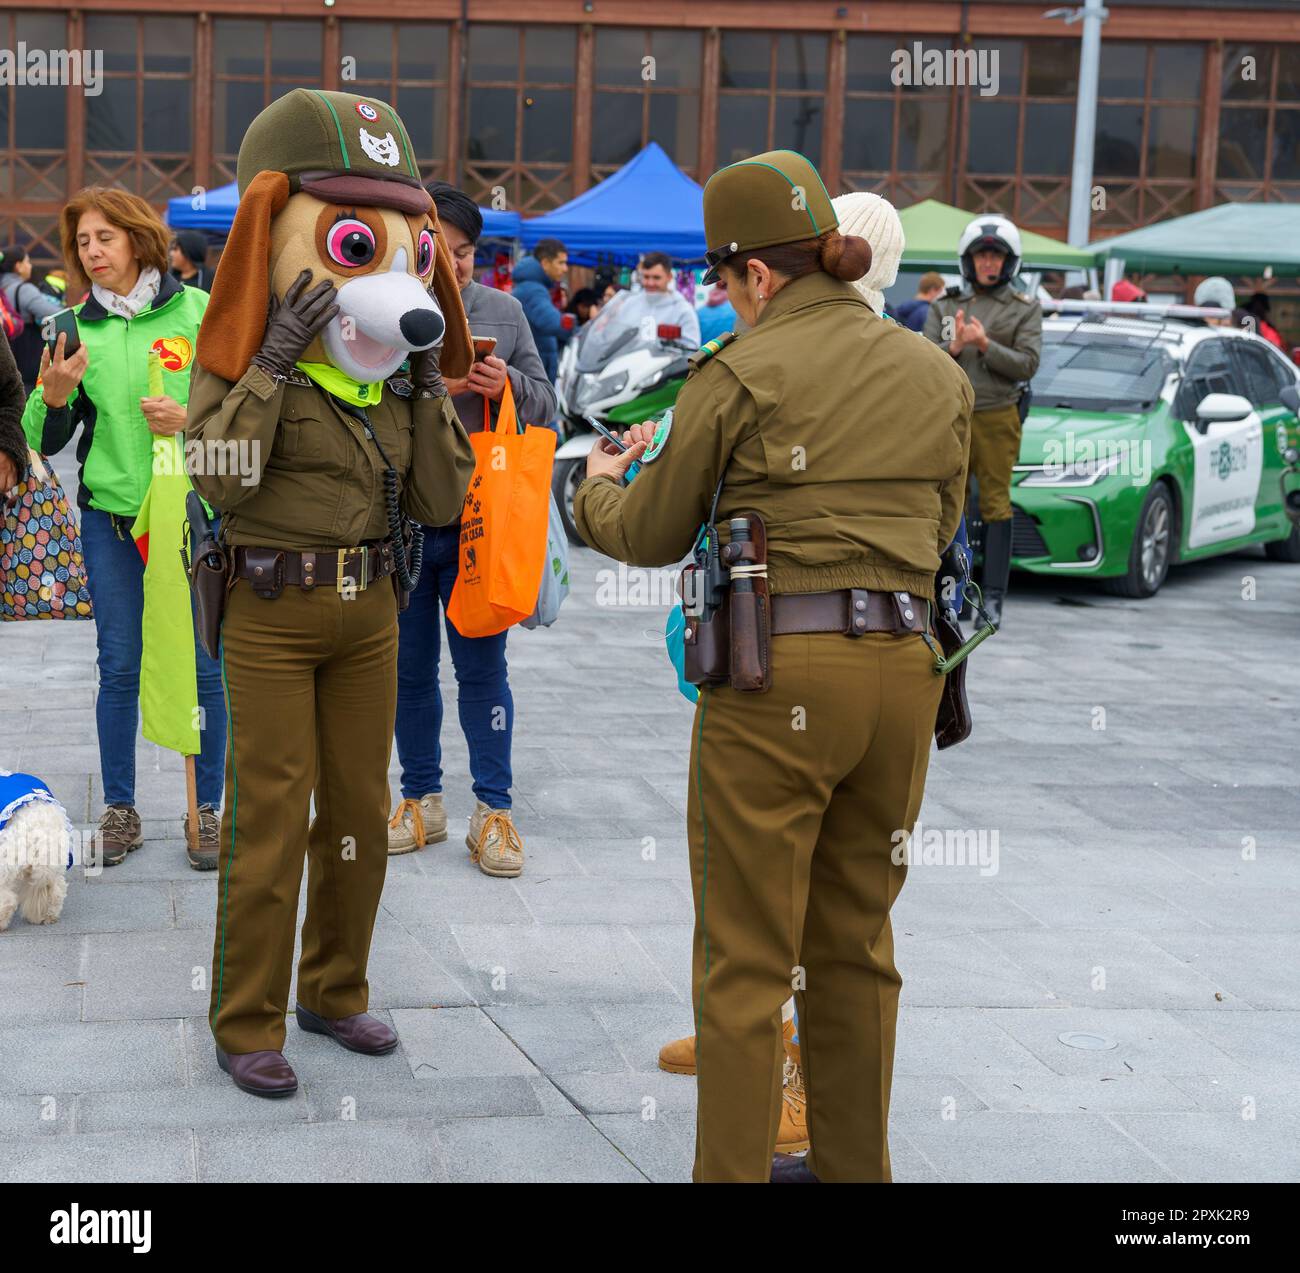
[703,151,840,283]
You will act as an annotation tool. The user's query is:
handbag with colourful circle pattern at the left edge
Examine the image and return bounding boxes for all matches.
[0,451,91,620]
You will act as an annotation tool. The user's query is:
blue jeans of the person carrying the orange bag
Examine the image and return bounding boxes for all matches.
[397,523,515,809]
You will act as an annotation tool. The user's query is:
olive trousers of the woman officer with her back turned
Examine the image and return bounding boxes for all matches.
[686,632,943,1182]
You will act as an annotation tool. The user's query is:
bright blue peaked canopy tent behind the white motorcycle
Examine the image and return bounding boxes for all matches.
[520,142,706,265]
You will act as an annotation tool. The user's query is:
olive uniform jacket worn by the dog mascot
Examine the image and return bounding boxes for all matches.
[185,367,475,551]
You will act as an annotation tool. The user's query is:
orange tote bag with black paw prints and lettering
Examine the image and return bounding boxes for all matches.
[447,380,555,636]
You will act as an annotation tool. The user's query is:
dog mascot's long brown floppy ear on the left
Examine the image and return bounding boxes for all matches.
[196,172,289,381]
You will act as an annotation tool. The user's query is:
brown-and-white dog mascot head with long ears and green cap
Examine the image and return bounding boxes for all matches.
[198,88,473,382]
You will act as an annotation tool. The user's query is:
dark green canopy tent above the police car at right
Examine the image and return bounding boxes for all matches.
[1089,203,1300,278]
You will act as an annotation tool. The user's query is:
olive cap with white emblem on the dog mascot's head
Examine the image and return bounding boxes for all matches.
[235,88,432,212]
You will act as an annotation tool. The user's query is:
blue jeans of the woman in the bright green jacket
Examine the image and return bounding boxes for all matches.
[81,508,226,809]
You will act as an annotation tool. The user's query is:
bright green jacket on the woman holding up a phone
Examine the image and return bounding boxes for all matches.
[22,273,208,518]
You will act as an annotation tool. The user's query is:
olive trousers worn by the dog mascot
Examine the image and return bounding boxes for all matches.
[209,579,398,1053]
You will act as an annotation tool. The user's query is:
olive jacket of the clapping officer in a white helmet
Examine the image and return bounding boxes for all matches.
[926,283,1043,411]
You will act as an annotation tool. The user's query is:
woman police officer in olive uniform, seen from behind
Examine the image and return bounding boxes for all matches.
[575,151,972,1181]
